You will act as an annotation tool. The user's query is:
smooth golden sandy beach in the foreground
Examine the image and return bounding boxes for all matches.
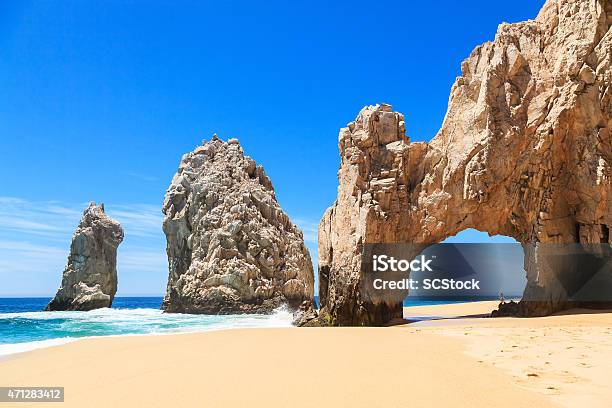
[0,302,612,408]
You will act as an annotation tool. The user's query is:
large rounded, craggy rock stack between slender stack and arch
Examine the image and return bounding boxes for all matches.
[162,135,314,314]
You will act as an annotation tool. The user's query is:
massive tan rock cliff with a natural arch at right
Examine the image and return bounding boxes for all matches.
[319,0,612,325]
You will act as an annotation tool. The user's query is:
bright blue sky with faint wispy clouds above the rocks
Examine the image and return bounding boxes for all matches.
[0,0,543,296]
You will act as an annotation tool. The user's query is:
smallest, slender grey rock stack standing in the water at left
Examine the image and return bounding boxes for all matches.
[46,203,123,311]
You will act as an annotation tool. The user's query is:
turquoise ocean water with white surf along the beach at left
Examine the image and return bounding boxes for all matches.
[0,297,292,356]
